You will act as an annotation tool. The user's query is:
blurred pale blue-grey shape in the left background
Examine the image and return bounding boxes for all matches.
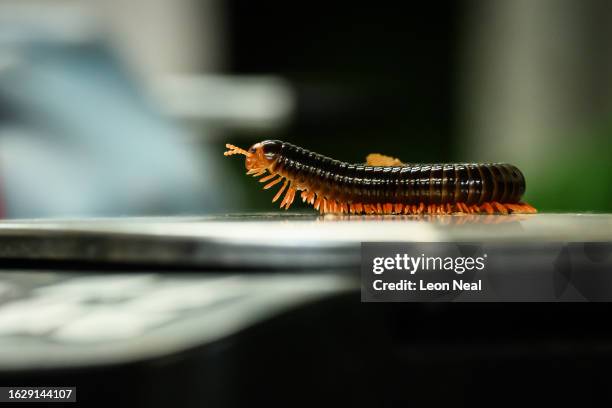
[0,41,231,217]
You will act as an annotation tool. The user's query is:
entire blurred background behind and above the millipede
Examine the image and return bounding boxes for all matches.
[0,0,612,217]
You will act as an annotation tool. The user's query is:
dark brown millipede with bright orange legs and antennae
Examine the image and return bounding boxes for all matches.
[224,140,537,215]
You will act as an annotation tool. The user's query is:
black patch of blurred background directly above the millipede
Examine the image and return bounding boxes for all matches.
[229,1,462,155]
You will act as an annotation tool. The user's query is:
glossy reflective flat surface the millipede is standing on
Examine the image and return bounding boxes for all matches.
[0,212,612,270]
